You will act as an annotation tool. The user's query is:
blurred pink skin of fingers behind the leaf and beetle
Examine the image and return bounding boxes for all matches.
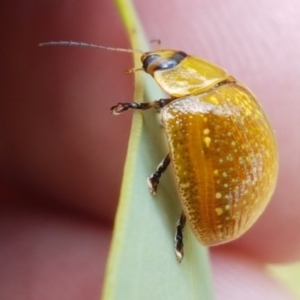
[0,0,300,300]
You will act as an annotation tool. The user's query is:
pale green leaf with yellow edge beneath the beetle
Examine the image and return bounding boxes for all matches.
[102,0,213,300]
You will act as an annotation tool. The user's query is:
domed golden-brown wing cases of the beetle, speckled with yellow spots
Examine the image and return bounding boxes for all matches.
[161,83,278,246]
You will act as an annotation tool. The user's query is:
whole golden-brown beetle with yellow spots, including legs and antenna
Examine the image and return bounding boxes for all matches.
[41,41,278,262]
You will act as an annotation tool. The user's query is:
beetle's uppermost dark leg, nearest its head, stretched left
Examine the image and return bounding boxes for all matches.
[110,99,174,115]
